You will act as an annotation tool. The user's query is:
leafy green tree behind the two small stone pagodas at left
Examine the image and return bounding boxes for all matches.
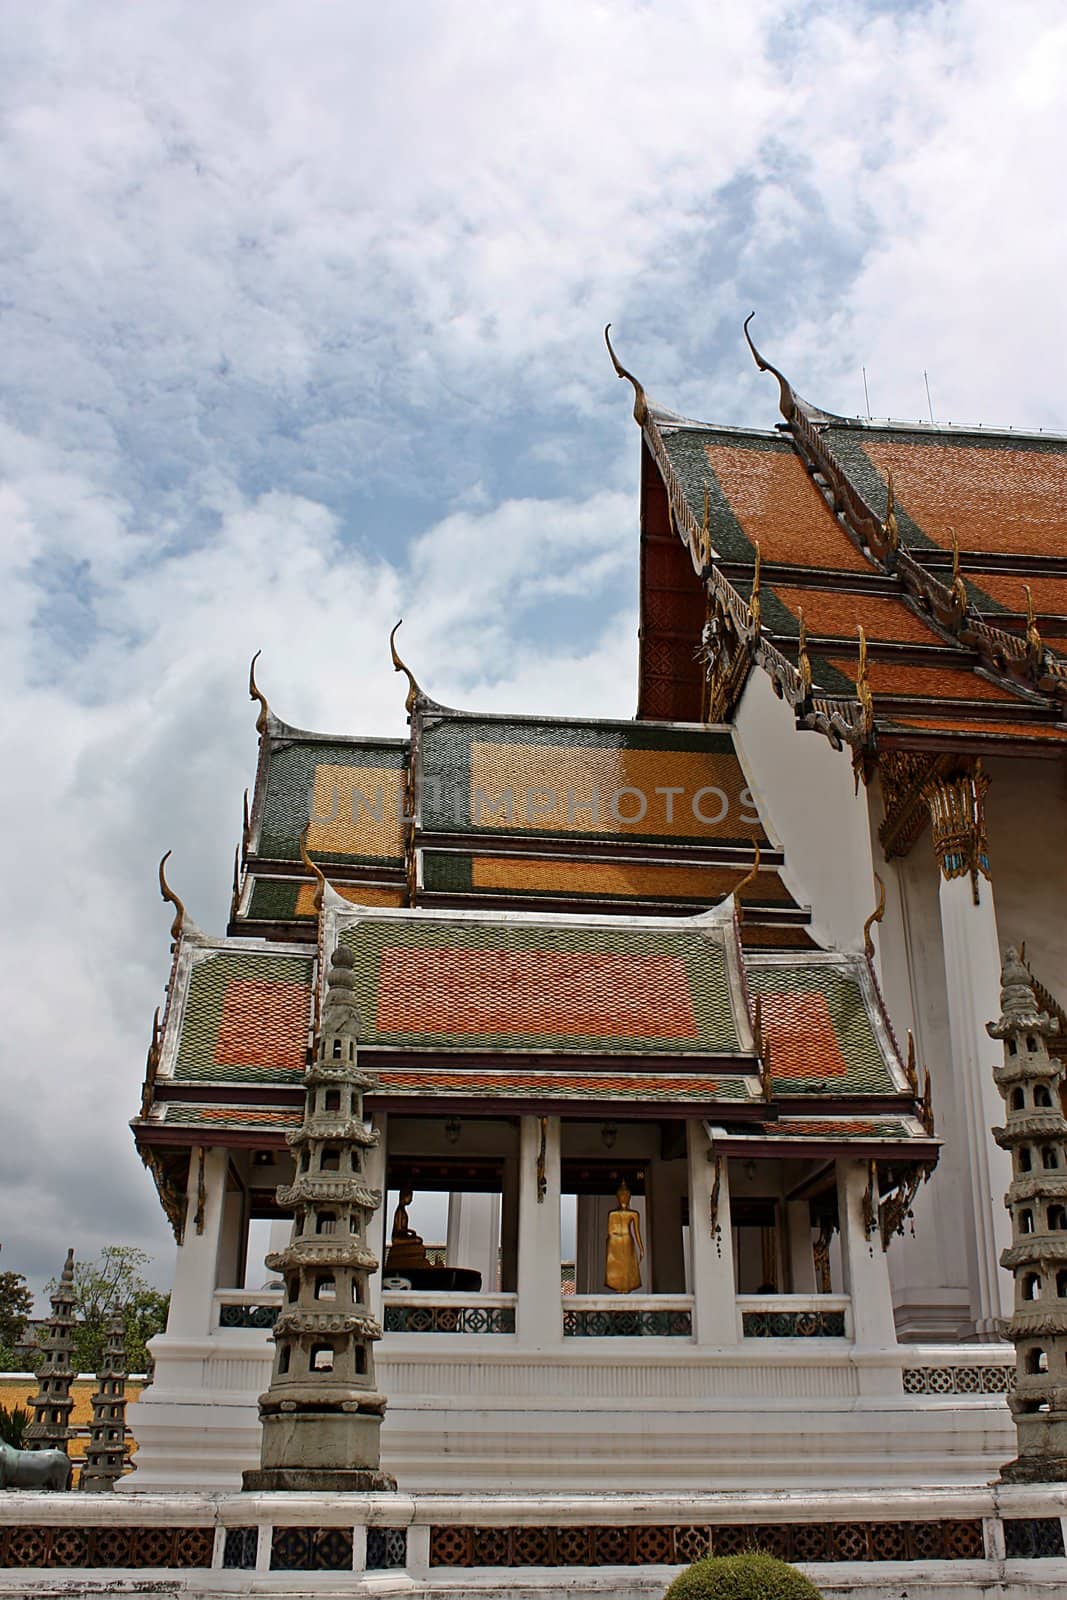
[48,1245,170,1373]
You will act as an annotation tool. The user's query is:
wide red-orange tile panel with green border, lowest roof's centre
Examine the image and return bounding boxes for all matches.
[341,917,739,1054]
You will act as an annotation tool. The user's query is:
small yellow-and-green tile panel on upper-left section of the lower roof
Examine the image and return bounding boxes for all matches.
[256,739,405,866]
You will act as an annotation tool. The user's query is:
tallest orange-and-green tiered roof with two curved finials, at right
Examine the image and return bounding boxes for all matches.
[617,324,1067,758]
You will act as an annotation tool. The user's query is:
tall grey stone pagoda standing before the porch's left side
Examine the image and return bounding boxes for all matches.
[245,947,397,1491]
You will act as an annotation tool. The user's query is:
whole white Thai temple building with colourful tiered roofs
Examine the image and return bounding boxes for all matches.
[122,328,1067,1493]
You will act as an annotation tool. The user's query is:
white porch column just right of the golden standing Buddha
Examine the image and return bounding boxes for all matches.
[686,1117,741,1349]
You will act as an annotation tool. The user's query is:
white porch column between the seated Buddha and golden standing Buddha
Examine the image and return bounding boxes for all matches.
[515,1117,563,1349]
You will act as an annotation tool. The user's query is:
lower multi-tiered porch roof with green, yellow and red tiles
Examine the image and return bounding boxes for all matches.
[134,691,936,1213]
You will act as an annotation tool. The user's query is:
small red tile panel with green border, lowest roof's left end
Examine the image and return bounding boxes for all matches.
[168,947,312,1083]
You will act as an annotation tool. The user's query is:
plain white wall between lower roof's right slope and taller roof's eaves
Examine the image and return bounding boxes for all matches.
[734,670,875,950]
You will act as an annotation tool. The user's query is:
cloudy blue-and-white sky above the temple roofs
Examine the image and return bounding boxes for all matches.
[0,0,1067,1283]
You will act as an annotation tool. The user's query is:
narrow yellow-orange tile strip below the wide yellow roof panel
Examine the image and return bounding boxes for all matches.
[422,851,795,906]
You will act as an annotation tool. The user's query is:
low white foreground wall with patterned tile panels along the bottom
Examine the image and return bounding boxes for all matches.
[0,1483,1067,1600]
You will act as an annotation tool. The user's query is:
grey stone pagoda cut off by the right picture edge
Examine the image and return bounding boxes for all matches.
[989,949,1067,1483]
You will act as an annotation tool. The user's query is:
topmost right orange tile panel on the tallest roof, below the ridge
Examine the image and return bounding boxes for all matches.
[862,438,1067,555]
